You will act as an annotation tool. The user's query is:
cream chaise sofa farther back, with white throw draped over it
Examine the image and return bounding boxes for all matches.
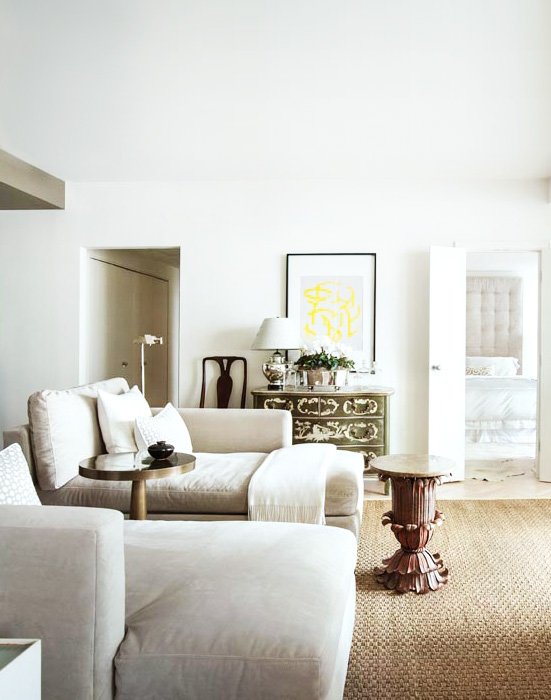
[4,378,363,536]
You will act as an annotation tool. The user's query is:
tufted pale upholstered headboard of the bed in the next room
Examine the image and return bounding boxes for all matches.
[466,275,522,372]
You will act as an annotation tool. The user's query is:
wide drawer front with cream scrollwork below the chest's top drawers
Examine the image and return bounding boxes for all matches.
[293,418,384,445]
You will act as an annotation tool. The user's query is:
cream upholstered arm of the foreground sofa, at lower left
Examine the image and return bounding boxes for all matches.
[0,506,125,700]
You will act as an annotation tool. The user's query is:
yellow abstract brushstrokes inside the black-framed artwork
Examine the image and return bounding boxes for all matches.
[303,278,362,344]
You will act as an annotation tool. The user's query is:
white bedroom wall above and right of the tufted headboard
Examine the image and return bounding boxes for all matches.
[467,251,539,377]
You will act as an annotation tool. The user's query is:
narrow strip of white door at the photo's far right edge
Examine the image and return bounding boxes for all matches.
[537,248,551,481]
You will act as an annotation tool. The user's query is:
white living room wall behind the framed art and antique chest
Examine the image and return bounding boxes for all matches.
[0,179,551,452]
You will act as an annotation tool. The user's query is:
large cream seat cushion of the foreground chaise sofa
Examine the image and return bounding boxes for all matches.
[115,521,356,700]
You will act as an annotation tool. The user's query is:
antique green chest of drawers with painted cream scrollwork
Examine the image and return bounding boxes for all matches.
[252,386,394,477]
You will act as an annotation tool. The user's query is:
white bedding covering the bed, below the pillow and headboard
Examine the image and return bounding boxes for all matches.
[465,376,537,443]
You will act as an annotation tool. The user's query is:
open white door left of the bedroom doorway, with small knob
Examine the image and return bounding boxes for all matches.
[428,246,467,481]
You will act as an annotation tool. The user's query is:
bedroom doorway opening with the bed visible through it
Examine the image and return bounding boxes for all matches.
[465,251,540,486]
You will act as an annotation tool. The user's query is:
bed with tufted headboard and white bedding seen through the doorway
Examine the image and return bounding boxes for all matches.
[465,275,537,444]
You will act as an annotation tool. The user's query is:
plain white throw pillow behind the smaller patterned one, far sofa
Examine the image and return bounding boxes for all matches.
[98,386,151,454]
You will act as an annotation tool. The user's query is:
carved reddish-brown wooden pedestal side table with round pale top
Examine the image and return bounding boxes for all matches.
[371,455,454,593]
